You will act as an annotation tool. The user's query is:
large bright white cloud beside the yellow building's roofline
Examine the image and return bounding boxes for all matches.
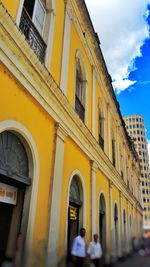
[86,0,150,92]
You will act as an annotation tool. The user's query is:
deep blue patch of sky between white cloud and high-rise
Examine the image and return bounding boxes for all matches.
[116,5,150,140]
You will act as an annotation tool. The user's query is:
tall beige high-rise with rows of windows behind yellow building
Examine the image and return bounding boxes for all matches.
[124,115,150,231]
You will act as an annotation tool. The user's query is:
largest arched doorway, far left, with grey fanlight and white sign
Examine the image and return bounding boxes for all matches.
[0,131,31,265]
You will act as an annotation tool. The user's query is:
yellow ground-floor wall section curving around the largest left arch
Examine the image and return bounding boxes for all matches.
[0,65,54,266]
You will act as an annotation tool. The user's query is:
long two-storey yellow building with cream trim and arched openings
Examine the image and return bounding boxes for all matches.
[0,0,142,267]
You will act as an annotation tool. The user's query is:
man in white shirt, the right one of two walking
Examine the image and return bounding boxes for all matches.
[87,234,102,267]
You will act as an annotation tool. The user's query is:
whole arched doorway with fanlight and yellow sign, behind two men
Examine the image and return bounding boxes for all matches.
[68,175,83,257]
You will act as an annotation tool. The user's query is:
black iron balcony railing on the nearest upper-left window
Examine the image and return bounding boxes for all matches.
[19,8,46,62]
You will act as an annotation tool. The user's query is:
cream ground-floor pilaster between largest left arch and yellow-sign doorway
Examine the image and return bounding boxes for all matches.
[46,123,67,267]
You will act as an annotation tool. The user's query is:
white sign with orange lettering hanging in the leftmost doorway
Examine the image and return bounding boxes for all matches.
[0,183,18,205]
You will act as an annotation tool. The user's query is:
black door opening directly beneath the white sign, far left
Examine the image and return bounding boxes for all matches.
[0,202,13,265]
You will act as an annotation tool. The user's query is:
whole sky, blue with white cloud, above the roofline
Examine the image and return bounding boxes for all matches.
[85,0,150,157]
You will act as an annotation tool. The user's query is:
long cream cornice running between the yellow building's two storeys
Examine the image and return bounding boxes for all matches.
[0,4,141,211]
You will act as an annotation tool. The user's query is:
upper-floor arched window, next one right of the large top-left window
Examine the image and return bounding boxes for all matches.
[75,51,87,122]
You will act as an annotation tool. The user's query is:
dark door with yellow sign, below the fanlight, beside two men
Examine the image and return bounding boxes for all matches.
[68,203,79,258]
